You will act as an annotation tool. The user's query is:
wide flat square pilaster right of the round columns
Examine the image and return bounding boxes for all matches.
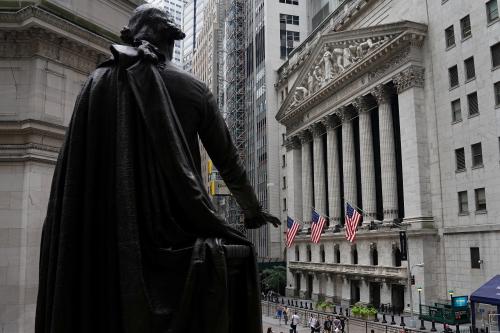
[393,66,437,221]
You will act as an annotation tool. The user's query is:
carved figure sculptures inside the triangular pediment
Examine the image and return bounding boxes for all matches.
[291,36,389,107]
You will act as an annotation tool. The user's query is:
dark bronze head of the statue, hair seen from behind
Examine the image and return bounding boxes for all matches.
[120,4,186,47]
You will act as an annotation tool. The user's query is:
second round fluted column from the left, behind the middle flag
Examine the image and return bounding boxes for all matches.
[311,123,326,216]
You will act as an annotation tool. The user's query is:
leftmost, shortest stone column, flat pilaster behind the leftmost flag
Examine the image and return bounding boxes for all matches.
[285,136,303,221]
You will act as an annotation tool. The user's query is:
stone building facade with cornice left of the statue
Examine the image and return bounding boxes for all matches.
[0,0,141,333]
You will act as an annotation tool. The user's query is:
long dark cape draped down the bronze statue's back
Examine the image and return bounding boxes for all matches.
[35,46,262,333]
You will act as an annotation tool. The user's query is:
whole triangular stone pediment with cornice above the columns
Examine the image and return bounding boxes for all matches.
[276,21,427,122]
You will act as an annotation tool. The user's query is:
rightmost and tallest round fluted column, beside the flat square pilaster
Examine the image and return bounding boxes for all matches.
[372,85,398,221]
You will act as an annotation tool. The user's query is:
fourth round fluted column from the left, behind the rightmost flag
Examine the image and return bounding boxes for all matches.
[338,107,358,206]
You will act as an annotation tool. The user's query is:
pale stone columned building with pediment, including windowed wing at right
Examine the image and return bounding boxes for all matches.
[275,0,500,310]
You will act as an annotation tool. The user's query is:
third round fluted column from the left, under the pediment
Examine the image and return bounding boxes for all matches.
[323,115,342,226]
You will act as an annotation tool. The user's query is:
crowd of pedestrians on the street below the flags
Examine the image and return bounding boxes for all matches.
[267,305,344,333]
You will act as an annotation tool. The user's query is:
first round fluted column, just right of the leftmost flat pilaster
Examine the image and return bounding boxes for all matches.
[299,130,313,227]
